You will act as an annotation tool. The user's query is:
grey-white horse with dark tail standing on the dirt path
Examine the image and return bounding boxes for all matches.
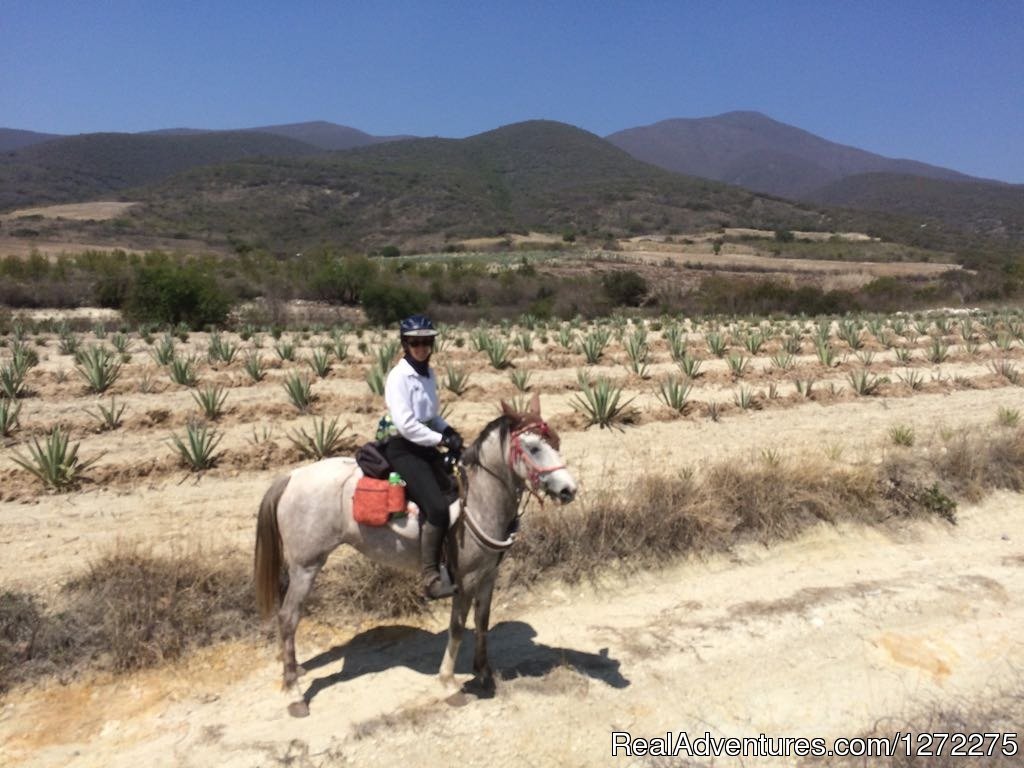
[254,394,577,717]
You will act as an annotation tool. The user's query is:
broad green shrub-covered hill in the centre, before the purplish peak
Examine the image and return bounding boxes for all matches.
[118,121,823,252]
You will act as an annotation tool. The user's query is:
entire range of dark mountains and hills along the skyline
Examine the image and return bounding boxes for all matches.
[0,112,1024,253]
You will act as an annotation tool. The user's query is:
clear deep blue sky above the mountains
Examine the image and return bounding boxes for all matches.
[6,0,1024,183]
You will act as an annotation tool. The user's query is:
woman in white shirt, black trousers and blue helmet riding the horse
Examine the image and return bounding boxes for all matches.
[384,314,462,600]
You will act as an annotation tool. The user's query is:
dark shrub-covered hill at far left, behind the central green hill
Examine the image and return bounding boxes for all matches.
[0,131,321,211]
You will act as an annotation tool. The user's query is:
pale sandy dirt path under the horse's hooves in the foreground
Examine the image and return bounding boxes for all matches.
[0,494,1024,768]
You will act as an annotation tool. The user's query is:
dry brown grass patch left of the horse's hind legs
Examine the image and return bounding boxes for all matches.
[0,547,257,690]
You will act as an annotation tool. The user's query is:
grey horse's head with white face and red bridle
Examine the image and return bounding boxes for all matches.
[502,393,577,504]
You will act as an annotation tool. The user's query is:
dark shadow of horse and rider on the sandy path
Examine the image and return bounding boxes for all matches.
[302,622,630,706]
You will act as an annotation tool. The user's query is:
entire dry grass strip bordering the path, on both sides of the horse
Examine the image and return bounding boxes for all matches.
[8,430,1024,690]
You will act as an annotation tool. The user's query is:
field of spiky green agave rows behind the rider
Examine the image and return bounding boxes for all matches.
[0,311,1024,493]
